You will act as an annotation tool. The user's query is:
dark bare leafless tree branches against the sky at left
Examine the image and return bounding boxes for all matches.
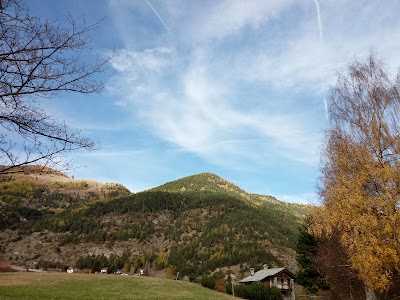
[0,0,111,174]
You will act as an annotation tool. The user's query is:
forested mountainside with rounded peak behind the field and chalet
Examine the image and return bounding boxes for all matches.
[0,169,306,276]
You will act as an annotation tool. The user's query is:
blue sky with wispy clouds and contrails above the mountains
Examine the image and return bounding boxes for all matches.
[24,0,400,204]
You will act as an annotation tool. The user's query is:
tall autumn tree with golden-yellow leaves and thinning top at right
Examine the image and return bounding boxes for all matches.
[310,54,400,299]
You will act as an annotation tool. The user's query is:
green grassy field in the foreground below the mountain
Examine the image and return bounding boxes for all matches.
[0,272,236,300]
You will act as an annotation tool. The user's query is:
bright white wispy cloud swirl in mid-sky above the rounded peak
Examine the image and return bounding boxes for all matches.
[108,47,318,167]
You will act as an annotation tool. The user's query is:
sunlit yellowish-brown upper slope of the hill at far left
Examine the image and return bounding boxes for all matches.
[0,168,130,213]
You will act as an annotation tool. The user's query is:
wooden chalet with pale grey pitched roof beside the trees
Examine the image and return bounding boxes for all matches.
[239,265,295,300]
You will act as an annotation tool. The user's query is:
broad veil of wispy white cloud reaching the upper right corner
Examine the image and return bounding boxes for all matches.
[99,0,400,201]
